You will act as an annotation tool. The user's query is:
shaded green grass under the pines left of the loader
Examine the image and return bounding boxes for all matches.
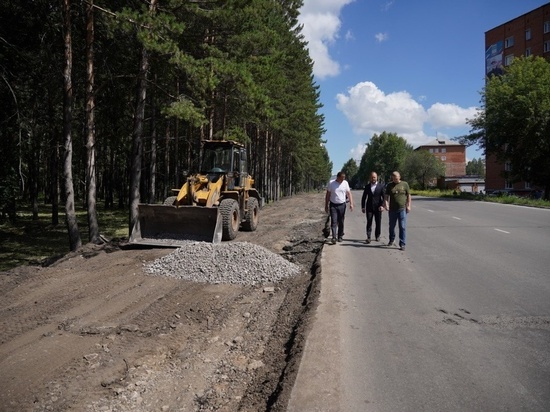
[0,205,128,271]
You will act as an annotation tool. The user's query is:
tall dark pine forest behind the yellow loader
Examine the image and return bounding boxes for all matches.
[0,0,332,250]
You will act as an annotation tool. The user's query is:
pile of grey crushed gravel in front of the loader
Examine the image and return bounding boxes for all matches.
[144,241,301,285]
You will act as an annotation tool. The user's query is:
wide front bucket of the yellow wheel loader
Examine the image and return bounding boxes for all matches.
[128,204,222,247]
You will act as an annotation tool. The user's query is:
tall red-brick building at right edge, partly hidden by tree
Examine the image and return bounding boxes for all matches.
[485,3,550,194]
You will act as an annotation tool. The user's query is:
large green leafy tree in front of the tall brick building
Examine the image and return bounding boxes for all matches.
[459,56,550,199]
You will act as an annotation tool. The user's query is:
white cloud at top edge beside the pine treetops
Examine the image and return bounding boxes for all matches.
[299,0,355,79]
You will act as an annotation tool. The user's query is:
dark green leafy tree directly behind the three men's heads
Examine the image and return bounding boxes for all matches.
[358,131,413,182]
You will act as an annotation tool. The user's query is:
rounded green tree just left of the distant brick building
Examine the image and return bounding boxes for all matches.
[401,150,445,189]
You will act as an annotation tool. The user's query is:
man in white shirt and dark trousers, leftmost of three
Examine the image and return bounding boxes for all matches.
[325,171,353,244]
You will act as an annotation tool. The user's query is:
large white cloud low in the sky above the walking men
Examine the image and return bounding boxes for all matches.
[336,82,477,151]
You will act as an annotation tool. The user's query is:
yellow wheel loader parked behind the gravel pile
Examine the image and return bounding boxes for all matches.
[133,140,262,247]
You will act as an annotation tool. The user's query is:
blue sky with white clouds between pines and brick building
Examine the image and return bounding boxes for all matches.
[300,0,547,173]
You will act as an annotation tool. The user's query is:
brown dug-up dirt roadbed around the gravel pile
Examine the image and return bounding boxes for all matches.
[0,193,326,411]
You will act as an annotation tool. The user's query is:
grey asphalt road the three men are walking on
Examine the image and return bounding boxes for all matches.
[288,196,550,411]
